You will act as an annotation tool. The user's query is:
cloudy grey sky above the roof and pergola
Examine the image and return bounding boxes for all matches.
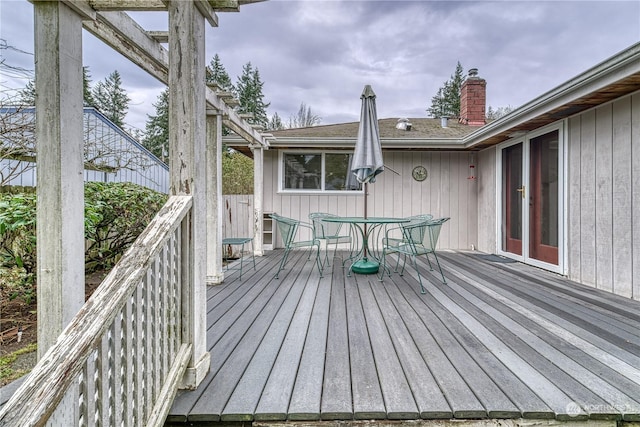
[0,0,640,132]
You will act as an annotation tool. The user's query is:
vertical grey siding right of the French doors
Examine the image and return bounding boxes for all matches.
[567,93,640,300]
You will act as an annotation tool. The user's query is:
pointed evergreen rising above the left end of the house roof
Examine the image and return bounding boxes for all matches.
[236,62,271,129]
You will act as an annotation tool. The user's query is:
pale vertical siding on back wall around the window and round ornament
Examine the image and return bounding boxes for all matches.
[264,150,478,249]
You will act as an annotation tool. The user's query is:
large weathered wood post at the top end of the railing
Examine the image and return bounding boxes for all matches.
[168,1,210,388]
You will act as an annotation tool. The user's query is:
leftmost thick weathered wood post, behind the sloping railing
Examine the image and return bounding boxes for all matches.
[33,1,84,425]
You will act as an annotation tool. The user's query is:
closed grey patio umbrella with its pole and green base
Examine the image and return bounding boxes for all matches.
[351,85,384,274]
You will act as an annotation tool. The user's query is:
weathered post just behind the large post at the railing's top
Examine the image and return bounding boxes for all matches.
[206,110,224,285]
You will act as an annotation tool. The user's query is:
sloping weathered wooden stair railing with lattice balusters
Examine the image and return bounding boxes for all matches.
[0,196,192,427]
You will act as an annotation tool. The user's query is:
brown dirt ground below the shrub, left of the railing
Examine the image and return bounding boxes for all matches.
[0,271,108,387]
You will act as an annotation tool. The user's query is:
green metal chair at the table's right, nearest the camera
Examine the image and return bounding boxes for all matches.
[380,218,449,294]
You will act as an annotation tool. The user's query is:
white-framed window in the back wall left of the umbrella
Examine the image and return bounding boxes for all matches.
[280,152,362,191]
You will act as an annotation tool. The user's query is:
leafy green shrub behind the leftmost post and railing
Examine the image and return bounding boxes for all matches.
[0,182,167,302]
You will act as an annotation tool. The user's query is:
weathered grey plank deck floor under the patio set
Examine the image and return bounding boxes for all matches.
[167,251,640,425]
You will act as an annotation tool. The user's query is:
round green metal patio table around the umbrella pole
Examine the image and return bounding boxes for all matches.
[322,216,410,274]
